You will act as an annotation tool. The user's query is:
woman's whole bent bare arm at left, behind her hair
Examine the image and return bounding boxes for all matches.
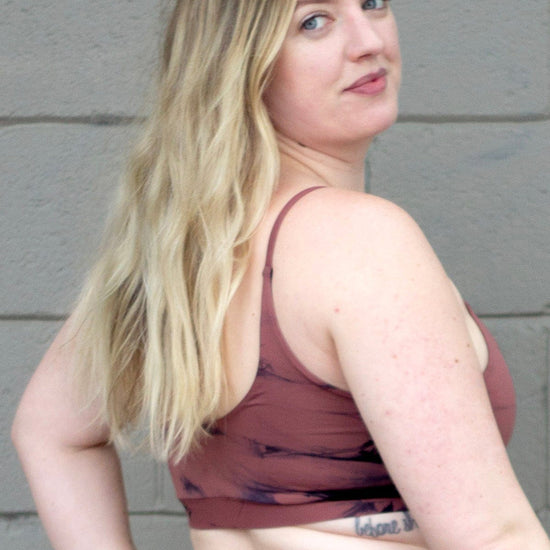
[12,324,134,549]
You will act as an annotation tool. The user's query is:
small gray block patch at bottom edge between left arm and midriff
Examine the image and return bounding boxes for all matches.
[130,515,193,550]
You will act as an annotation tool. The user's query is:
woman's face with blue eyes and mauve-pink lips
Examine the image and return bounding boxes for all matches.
[264,0,401,155]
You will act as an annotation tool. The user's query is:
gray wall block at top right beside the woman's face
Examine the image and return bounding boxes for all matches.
[392,0,550,117]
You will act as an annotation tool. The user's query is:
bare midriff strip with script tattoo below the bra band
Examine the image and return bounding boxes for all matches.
[191,512,428,550]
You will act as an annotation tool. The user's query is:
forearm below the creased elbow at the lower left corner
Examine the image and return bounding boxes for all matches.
[14,435,134,550]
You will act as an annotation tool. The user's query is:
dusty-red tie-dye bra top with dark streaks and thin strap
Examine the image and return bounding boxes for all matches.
[170,188,515,529]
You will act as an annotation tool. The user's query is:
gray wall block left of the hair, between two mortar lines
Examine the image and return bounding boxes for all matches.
[0,124,132,315]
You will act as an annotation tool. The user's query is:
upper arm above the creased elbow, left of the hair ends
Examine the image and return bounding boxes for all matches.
[12,320,109,448]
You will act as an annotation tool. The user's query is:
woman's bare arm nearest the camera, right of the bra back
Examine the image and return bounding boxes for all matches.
[323,192,540,549]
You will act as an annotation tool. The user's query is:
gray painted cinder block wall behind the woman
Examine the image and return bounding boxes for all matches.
[0,0,550,550]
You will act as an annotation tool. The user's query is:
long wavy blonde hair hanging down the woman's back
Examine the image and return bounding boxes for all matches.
[74,0,295,459]
